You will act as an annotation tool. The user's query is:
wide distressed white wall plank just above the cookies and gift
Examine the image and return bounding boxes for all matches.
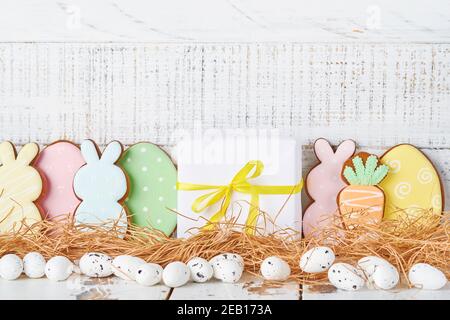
[0,43,450,148]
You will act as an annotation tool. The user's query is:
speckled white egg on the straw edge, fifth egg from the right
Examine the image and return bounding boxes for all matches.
[299,247,336,273]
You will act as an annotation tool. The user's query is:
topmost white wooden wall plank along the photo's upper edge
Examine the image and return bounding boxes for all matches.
[0,0,450,42]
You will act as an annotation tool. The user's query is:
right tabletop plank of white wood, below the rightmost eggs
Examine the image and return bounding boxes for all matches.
[302,284,450,300]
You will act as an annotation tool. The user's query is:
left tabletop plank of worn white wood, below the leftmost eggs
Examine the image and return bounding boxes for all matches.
[0,274,170,300]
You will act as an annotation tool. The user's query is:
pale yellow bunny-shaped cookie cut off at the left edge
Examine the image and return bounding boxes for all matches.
[0,141,42,233]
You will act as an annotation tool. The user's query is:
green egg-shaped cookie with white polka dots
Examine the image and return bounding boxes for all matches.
[119,142,177,235]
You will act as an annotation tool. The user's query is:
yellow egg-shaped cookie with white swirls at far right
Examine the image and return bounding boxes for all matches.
[379,144,444,219]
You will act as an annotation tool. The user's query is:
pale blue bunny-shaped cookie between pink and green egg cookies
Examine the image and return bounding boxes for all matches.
[73,140,128,233]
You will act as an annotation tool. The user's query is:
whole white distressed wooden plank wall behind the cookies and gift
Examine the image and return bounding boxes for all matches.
[0,0,450,298]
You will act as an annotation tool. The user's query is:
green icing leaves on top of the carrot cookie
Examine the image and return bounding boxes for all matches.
[343,155,389,186]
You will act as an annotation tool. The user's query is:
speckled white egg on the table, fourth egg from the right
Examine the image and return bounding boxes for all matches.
[328,263,365,291]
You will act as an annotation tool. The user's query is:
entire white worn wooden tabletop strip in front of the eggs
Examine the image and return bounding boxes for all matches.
[0,274,450,300]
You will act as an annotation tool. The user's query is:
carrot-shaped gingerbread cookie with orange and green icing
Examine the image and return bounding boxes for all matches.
[338,152,389,228]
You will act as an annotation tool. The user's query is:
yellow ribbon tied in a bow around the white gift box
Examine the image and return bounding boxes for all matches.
[177,160,303,233]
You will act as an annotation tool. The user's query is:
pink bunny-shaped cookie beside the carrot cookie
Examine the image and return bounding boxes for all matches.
[303,139,356,236]
